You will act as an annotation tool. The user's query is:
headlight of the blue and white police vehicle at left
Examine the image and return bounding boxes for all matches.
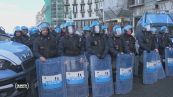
[0,59,23,72]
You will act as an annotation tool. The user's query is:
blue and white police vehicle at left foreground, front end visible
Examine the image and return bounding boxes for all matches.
[0,34,36,97]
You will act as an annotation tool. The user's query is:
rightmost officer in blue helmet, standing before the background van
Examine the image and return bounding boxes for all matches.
[157,26,173,58]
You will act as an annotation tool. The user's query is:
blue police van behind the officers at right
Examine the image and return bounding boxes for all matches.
[135,11,173,40]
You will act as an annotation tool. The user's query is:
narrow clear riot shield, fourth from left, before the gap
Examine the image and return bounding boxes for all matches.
[115,53,134,94]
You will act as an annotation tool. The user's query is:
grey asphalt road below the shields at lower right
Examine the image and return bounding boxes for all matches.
[112,77,173,97]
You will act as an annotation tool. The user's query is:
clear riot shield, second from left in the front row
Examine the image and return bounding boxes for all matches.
[64,55,89,97]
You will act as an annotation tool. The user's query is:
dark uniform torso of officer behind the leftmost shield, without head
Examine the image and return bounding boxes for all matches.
[33,34,57,58]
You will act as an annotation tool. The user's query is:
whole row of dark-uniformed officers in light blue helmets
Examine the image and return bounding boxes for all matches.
[12,21,173,71]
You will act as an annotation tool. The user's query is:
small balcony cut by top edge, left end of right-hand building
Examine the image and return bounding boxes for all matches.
[129,0,144,8]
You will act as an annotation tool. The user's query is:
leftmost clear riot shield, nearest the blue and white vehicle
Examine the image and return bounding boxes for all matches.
[36,58,66,97]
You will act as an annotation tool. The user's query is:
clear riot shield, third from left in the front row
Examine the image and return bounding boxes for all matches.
[90,55,114,97]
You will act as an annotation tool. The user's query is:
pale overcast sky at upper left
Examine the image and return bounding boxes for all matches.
[0,0,44,33]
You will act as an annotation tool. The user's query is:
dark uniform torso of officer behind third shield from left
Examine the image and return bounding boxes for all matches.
[86,33,109,59]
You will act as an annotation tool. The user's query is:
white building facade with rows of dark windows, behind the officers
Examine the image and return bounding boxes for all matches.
[64,0,103,28]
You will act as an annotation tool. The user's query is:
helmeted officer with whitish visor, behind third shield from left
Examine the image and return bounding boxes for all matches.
[86,21,108,59]
